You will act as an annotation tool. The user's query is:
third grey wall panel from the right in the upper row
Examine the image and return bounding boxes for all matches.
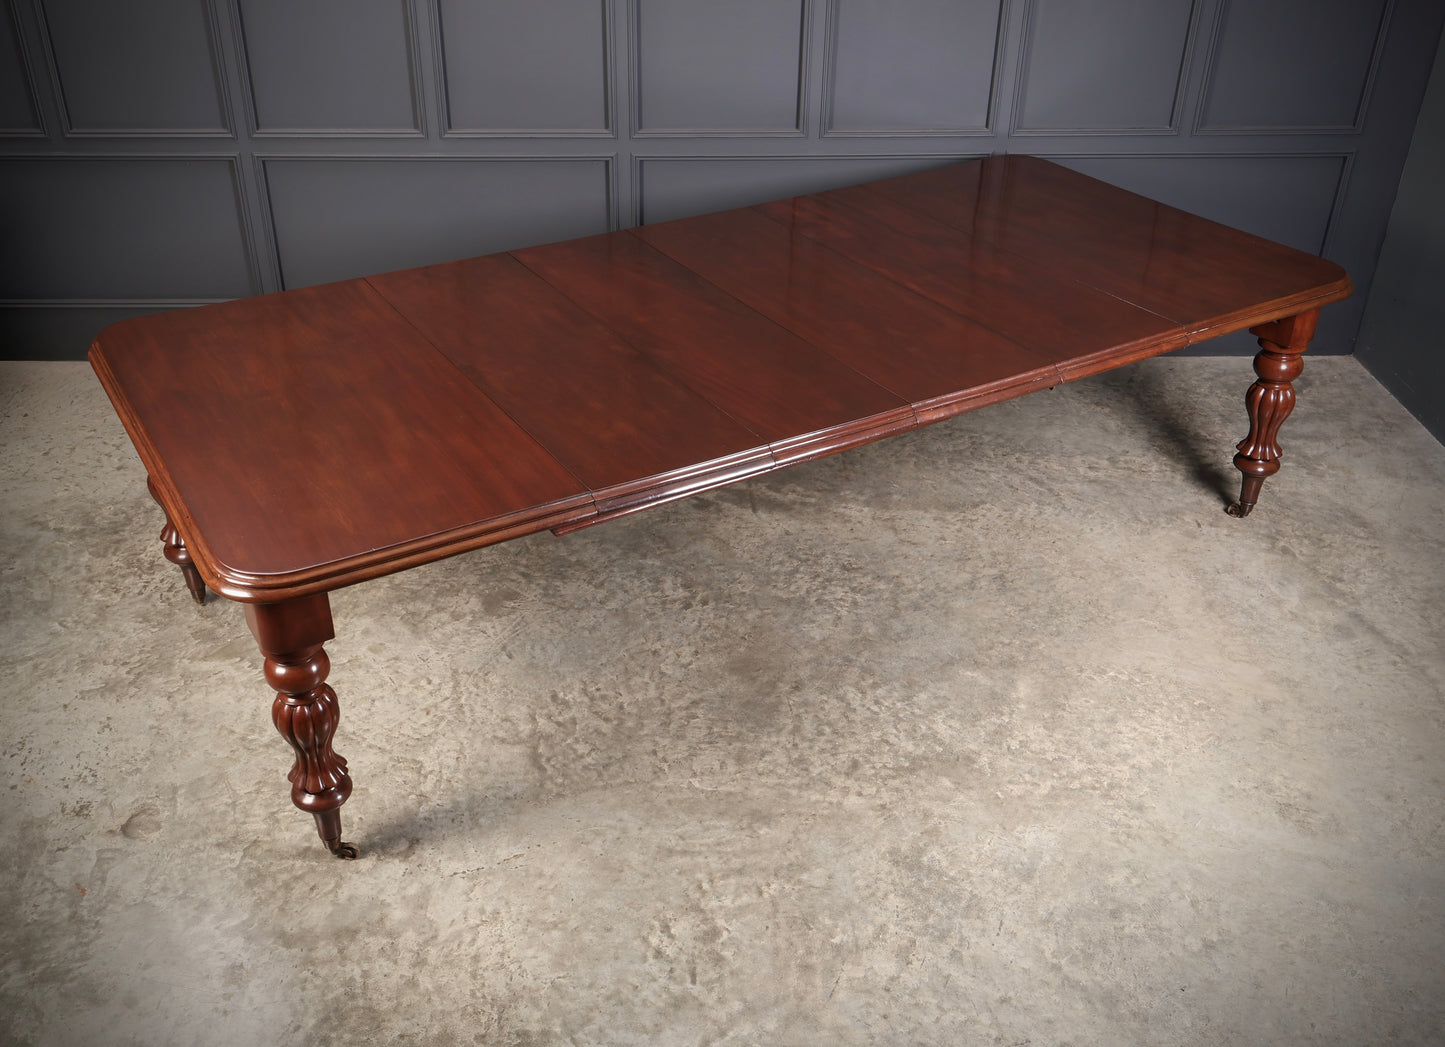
[827,0,1003,133]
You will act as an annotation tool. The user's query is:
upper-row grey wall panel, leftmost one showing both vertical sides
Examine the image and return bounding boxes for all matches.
[42,0,228,134]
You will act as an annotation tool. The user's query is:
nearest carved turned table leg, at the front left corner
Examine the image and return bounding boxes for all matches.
[246,592,358,858]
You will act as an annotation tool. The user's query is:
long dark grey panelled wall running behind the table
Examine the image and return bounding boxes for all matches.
[0,0,1445,358]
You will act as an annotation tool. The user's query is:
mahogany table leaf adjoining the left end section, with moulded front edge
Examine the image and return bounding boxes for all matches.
[368,256,773,511]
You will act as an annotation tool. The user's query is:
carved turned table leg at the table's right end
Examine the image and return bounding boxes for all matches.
[1227,309,1319,517]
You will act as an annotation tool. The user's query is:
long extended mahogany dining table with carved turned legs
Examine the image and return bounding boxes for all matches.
[90,156,1351,858]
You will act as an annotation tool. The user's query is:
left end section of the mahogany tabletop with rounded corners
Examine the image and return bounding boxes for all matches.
[87,280,591,581]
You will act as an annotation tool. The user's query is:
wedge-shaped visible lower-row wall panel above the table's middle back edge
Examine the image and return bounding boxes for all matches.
[637,156,967,222]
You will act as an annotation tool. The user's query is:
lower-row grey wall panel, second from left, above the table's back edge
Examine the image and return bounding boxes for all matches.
[264,156,610,287]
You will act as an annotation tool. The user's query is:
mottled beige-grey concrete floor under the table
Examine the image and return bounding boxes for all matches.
[0,358,1445,1047]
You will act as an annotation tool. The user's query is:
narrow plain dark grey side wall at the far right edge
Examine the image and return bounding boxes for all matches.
[1357,24,1445,443]
